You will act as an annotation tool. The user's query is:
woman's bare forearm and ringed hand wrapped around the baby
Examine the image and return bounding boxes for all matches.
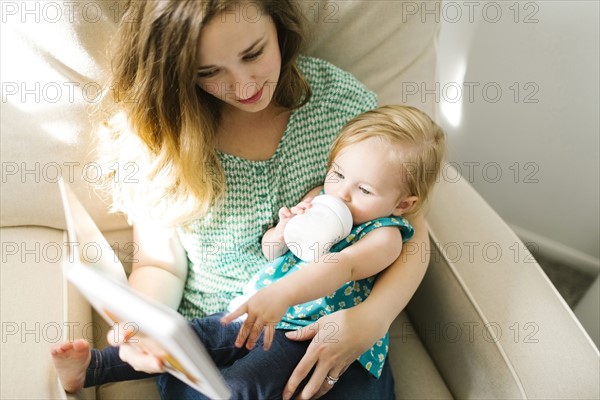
[283,214,429,399]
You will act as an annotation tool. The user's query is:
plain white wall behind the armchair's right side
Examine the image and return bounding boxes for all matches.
[434,1,600,270]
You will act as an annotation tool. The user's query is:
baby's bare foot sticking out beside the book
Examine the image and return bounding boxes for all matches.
[50,339,92,393]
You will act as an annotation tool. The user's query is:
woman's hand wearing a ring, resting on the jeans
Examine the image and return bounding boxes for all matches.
[283,305,388,400]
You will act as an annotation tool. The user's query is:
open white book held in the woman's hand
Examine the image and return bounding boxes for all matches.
[59,179,230,399]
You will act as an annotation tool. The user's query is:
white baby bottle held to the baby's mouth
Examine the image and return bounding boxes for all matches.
[283,194,352,262]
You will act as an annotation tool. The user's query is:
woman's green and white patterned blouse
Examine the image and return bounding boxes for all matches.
[179,57,377,319]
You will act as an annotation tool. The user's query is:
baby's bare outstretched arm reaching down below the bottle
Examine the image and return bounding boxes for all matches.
[223,227,402,349]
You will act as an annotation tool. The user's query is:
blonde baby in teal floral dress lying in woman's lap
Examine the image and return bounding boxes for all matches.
[52,106,446,398]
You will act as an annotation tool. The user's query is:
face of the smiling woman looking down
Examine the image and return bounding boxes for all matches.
[197,8,281,112]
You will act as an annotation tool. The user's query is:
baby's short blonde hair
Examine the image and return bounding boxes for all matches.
[328,105,446,215]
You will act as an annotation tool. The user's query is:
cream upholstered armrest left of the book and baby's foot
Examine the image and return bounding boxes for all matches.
[0,226,72,399]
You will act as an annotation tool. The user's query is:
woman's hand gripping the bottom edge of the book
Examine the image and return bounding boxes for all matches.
[107,323,167,374]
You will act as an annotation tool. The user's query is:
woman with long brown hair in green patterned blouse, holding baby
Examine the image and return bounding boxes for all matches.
[96,0,428,399]
